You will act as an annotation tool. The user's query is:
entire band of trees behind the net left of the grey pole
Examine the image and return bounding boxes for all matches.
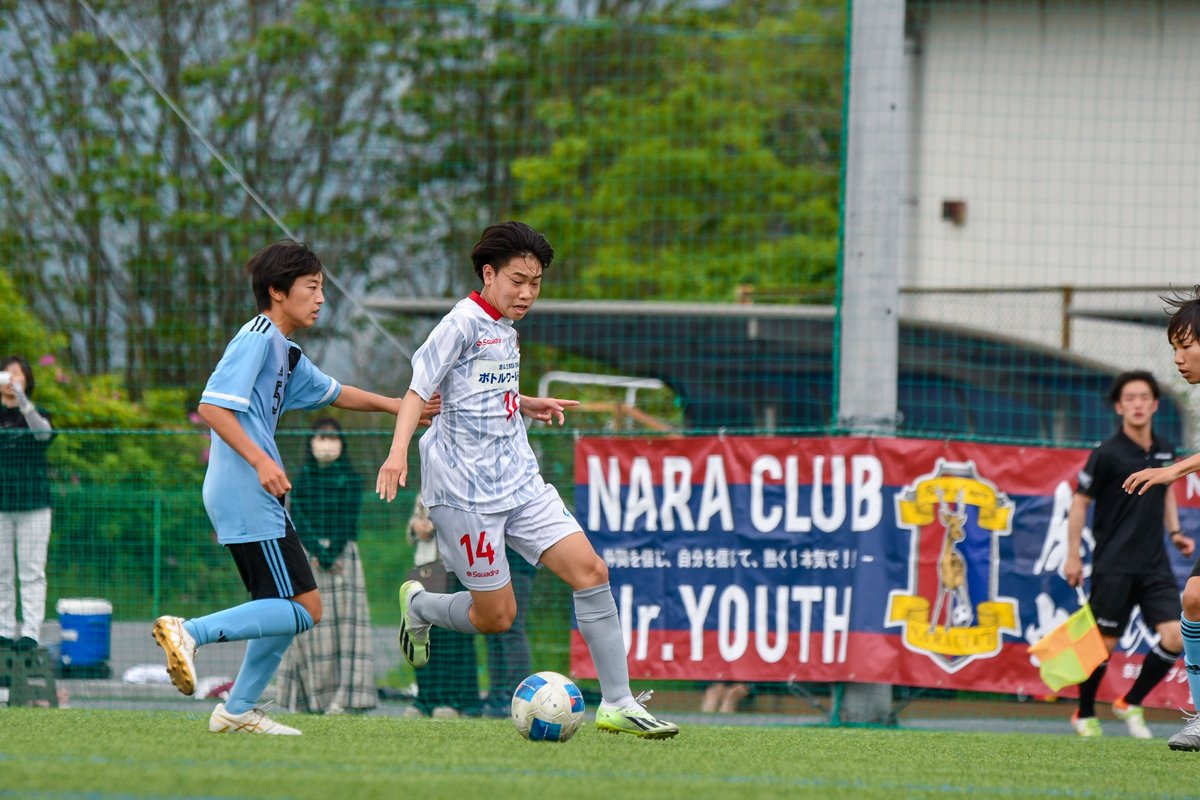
[0,0,844,419]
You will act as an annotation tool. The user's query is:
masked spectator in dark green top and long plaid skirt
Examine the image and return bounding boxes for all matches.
[280,417,378,714]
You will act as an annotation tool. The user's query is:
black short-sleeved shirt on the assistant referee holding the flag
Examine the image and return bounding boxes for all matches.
[1075,431,1175,575]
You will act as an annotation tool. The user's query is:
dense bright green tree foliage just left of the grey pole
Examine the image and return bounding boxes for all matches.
[514,2,845,301]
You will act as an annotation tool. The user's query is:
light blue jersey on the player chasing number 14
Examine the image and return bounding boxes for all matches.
[200,314,342,545]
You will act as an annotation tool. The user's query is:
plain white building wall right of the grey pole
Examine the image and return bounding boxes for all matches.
[902,0,1200,398]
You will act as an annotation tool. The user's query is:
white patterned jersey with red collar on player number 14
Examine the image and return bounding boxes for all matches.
[409,291,545,513]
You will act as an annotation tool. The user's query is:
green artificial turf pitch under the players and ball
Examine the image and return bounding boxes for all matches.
[0,708,1200,800]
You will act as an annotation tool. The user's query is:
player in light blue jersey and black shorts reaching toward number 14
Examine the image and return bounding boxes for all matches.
[154,240,436,735]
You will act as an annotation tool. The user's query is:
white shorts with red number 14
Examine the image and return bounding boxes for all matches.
[430,483,583,591]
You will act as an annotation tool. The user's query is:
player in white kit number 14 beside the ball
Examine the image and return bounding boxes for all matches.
[376,222,679,739]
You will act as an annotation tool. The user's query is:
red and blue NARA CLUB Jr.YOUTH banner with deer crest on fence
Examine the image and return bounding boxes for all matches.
[571,437,1200,708]
